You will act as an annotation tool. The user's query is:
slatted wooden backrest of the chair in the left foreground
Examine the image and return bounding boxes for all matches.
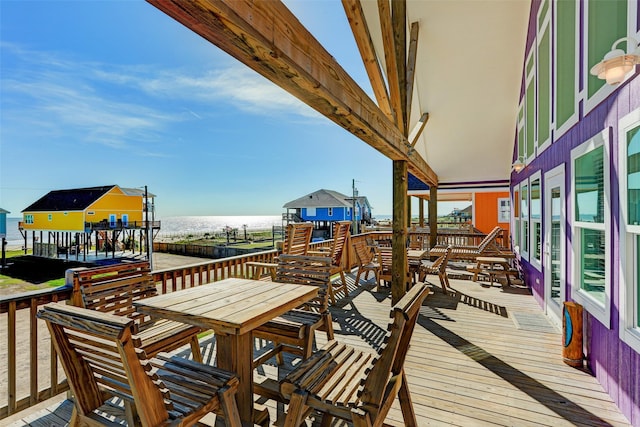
[38,303,173,425]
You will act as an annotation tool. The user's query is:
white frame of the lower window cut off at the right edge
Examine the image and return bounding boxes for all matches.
[618,108,640,352]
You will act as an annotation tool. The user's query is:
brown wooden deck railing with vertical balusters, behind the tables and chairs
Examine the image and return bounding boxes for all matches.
[0,231,502,419]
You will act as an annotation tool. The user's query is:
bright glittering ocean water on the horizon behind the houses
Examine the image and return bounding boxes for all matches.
[1,215,283,249]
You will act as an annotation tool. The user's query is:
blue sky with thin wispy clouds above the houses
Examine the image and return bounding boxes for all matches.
[0,0,464,218]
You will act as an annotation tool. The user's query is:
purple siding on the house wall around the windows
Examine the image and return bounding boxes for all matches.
[511,0,640,426]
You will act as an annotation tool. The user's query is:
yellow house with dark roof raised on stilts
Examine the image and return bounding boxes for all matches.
[18,185,159,257]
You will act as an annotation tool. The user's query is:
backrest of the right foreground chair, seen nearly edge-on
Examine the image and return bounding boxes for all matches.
[360,283,430,419]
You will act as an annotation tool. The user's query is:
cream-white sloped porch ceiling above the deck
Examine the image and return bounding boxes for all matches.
[362,0,530,184]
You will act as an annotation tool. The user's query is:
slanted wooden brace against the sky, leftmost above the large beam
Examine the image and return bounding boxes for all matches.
[342,0,395,122]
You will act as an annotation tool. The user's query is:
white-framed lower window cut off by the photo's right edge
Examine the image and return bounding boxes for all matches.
[618,109,640,352]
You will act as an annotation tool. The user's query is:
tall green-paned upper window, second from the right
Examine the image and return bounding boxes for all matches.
[554,1,579,136]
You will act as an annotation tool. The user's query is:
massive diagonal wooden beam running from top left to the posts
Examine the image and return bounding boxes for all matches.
[147,0,438,187]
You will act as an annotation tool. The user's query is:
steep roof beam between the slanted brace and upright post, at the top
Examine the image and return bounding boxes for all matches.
[378,0,403,129]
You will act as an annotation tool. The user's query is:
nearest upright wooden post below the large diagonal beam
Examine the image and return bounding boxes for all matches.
[391,160,409,305]
